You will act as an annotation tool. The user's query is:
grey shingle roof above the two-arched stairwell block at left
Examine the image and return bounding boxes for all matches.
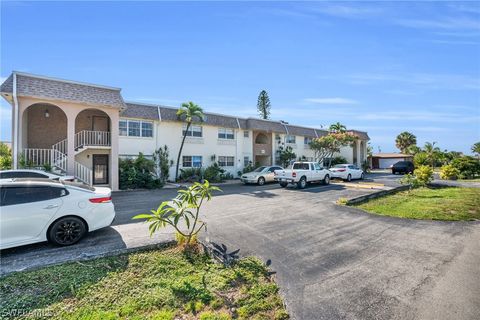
[0,71,125,108]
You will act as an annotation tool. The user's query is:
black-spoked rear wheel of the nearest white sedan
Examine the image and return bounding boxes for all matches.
[48,217,87,246]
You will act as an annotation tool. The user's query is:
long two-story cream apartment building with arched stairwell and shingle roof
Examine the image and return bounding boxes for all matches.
[0,72,369,190]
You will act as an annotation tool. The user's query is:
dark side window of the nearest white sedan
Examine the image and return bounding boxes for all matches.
[1,186,68,206]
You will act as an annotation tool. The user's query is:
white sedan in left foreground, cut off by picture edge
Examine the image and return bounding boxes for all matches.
[0,178,115,249]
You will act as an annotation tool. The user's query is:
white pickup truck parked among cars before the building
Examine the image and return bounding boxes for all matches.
[275,162,330,189]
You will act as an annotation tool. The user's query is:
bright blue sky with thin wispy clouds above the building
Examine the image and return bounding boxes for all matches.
[0,1,480,153]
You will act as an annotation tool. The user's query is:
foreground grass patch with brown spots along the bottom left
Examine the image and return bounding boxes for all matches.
[0,247,288,320]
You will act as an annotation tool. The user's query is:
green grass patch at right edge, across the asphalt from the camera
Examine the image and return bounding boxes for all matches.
[353,187,480,220]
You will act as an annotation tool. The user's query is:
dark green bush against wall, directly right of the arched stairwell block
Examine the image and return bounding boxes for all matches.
[119,153,163,190]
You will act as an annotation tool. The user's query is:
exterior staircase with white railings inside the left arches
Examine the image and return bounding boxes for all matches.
[23,130,110,185]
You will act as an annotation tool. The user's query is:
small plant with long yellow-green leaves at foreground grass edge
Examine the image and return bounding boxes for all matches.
[133,181,221,248]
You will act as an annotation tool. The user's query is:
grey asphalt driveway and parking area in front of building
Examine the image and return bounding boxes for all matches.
[2,177,480,320]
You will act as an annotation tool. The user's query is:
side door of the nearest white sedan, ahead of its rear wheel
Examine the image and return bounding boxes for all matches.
[0,185,67,247]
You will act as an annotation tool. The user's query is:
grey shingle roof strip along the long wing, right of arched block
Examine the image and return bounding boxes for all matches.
[120,102,370,140]
